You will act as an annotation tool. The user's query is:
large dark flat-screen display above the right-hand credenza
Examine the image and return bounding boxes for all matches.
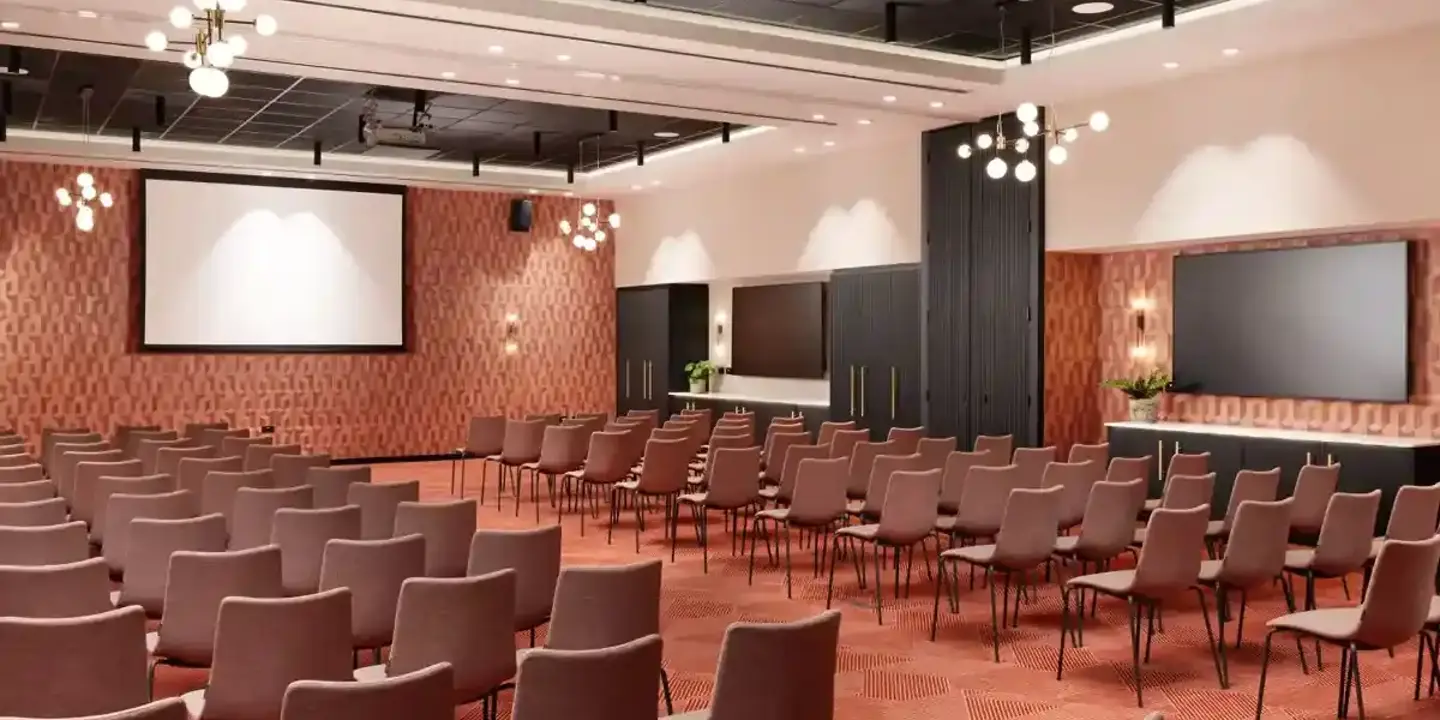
[1172,242,1410,402]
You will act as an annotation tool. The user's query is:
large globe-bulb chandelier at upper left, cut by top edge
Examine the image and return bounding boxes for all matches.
[145,0,276,98]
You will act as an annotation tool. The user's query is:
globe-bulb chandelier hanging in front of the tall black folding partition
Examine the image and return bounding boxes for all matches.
[955,3,1110,183]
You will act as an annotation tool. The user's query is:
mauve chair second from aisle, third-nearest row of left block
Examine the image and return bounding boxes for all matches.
[320,536,425,661]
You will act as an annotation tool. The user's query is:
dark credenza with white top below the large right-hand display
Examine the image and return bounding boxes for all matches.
[1106,422,1440,536]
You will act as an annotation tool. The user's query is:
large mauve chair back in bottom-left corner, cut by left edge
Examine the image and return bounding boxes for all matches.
[0,608,150,717]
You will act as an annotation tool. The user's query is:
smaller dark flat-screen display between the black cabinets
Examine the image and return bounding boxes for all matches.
[730,282,827,379]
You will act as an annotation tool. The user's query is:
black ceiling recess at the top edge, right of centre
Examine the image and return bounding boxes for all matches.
[615,0,1223,59]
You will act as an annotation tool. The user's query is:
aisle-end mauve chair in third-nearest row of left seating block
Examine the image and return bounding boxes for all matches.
[465,526,560,647]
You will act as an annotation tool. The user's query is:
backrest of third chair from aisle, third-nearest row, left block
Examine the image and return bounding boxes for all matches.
[154,546,285,667]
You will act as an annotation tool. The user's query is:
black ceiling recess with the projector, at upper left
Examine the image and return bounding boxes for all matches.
[0,48,742,170]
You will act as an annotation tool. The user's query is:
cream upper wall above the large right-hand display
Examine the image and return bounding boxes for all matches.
[1045,29,1440,251]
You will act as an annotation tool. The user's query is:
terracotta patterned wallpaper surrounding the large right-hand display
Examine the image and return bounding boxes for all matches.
[1045,229,1440,438]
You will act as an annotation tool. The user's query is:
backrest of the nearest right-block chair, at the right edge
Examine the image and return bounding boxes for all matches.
[1355,536,1440,648]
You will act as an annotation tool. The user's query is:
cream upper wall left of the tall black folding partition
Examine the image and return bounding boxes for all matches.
[615,134,920,287]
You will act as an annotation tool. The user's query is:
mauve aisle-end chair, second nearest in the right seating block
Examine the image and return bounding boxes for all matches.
[1056,505,1224,707]
